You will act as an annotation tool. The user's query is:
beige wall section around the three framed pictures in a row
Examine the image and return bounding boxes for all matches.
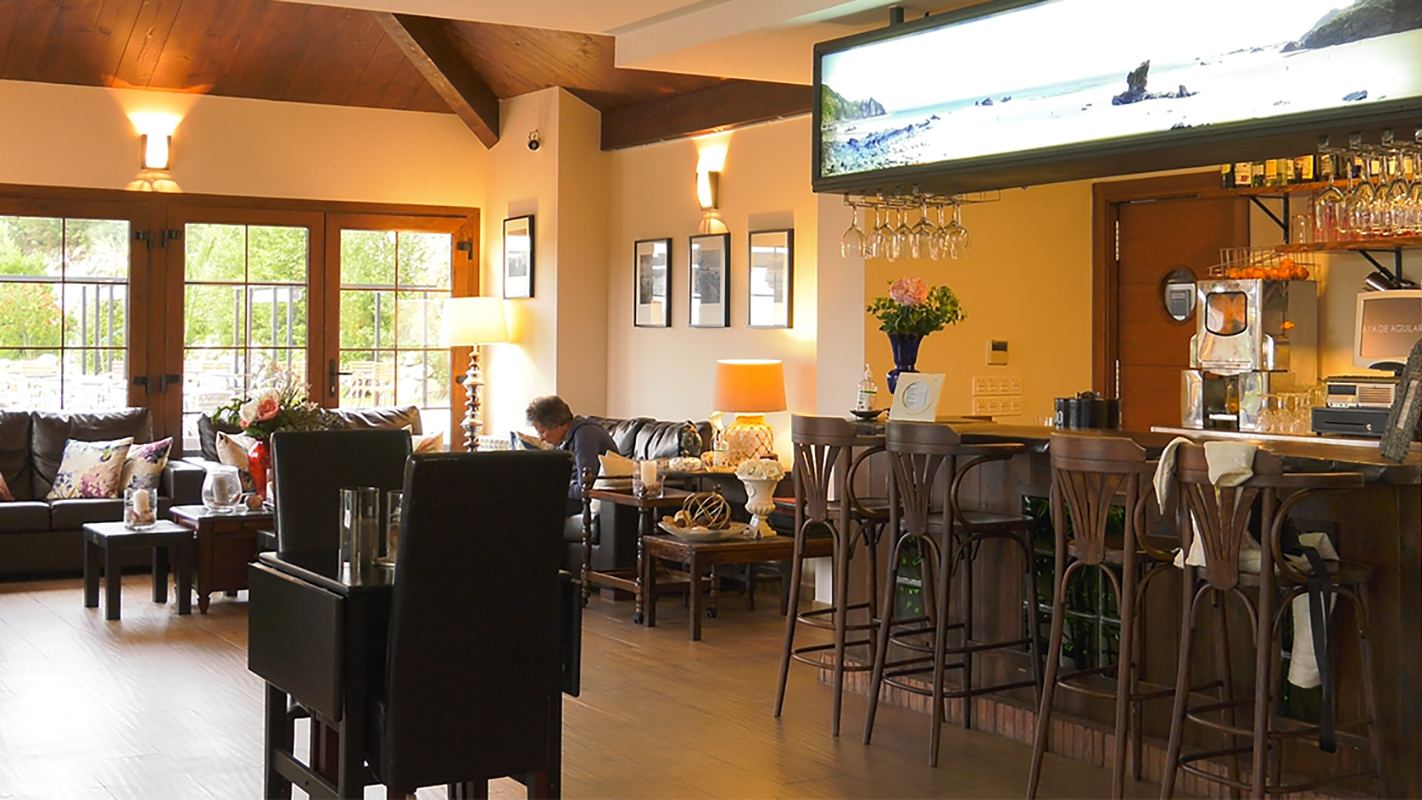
[606,118,824,456]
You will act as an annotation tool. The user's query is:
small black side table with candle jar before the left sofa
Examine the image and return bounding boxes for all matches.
[84,520,193,621]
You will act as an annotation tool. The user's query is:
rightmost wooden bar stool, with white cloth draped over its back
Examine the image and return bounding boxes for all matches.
[1160,445,1382,799]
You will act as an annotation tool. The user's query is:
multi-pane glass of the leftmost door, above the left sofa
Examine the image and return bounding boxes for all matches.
[0,216,134,411]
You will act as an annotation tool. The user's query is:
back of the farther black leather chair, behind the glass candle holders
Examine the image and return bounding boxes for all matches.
[272,431,410,553]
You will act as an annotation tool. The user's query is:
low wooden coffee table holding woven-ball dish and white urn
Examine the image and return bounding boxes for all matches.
[643,534,835,642]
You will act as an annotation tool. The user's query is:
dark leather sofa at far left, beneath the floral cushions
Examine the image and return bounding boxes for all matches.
[0,408,203,577]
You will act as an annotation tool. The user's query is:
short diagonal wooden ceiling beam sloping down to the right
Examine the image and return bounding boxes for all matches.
[371,11,499,148]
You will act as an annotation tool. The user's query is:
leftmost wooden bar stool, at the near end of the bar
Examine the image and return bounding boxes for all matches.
[775,415,889,736]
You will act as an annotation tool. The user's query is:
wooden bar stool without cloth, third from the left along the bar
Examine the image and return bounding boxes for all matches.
[1027,433,1183,797]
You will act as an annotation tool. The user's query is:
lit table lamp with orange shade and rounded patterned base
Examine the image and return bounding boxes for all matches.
[711,358,786,466]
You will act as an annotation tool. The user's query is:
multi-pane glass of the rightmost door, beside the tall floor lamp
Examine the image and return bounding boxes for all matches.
[336,227,454,443]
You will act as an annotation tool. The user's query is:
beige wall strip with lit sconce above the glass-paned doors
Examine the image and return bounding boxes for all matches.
[0,81,486,206]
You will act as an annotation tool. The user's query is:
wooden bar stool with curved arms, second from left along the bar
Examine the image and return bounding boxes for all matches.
[863,422,1042,766]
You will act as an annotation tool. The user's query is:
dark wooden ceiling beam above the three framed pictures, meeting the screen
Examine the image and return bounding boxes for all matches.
[603,81,813,151]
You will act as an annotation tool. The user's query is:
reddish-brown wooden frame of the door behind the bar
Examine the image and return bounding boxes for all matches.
[1091,171,1249,398]
